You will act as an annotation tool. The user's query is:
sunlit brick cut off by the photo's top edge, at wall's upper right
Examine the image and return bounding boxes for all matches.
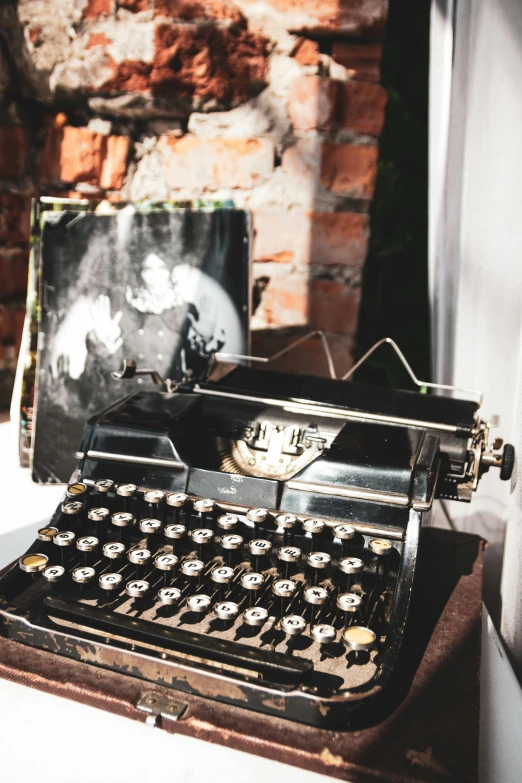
[232,0,388,38]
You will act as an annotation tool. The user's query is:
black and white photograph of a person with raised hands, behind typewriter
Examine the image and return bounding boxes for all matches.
[33,206,250,483]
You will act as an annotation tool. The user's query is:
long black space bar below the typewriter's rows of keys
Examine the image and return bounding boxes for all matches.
[45,595,313,685]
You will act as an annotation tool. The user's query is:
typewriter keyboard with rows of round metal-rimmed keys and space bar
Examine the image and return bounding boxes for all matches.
[13,479,402,694]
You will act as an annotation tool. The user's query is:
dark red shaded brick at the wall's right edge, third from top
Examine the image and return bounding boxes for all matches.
[339,81,388,136]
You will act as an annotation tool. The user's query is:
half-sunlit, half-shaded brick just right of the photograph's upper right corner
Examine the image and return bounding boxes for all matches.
[253,209,368,268]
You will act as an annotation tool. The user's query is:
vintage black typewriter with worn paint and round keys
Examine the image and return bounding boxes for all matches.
[0,340,514,727]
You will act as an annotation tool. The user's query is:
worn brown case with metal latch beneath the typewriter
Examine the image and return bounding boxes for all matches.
[0,528,484,783]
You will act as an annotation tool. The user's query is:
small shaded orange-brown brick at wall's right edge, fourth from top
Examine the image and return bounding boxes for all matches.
[321,144,378,199]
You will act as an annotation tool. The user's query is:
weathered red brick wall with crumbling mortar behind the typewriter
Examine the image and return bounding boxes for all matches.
[0,0,387,402]
